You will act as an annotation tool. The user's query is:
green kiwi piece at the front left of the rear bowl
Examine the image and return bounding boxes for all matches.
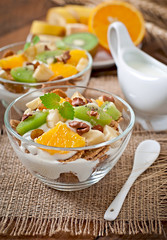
[10,67,36,83]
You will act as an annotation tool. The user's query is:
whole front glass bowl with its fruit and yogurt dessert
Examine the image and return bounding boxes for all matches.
[5,86,135,191]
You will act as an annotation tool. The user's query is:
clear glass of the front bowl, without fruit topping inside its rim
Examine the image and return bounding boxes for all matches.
[4,86,135,191]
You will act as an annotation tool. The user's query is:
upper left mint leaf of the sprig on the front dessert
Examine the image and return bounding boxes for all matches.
[40,93,60,109]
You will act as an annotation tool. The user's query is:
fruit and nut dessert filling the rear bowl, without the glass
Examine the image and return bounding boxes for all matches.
[0,36,89,93]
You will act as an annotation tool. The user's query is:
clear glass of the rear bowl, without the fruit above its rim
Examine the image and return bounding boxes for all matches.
[0,42,92,107]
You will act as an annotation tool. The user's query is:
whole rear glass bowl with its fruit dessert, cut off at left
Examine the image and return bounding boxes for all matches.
[0,40,92,106]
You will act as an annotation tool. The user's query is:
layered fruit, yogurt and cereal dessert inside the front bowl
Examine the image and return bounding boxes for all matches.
[10,89,123,183]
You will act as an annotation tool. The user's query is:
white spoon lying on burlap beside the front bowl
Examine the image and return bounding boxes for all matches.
[104,140,160,221]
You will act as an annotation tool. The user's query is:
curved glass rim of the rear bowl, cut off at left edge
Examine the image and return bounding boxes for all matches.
[0,41,93,87]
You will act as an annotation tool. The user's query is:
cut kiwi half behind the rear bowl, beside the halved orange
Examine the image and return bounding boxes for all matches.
[62,32,98,55]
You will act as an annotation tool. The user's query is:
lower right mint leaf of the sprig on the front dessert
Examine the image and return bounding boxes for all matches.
[58,102,74,120]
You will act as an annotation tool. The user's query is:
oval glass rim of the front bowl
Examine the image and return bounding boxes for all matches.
[4,85,135,151]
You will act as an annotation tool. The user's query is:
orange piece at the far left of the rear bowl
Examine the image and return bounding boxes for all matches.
[0,54,27,69]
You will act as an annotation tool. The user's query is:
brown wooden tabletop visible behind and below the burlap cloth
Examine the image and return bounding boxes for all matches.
[0,0,167,240]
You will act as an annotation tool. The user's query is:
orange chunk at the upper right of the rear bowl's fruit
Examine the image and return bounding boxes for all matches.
[67,49,87,66]
